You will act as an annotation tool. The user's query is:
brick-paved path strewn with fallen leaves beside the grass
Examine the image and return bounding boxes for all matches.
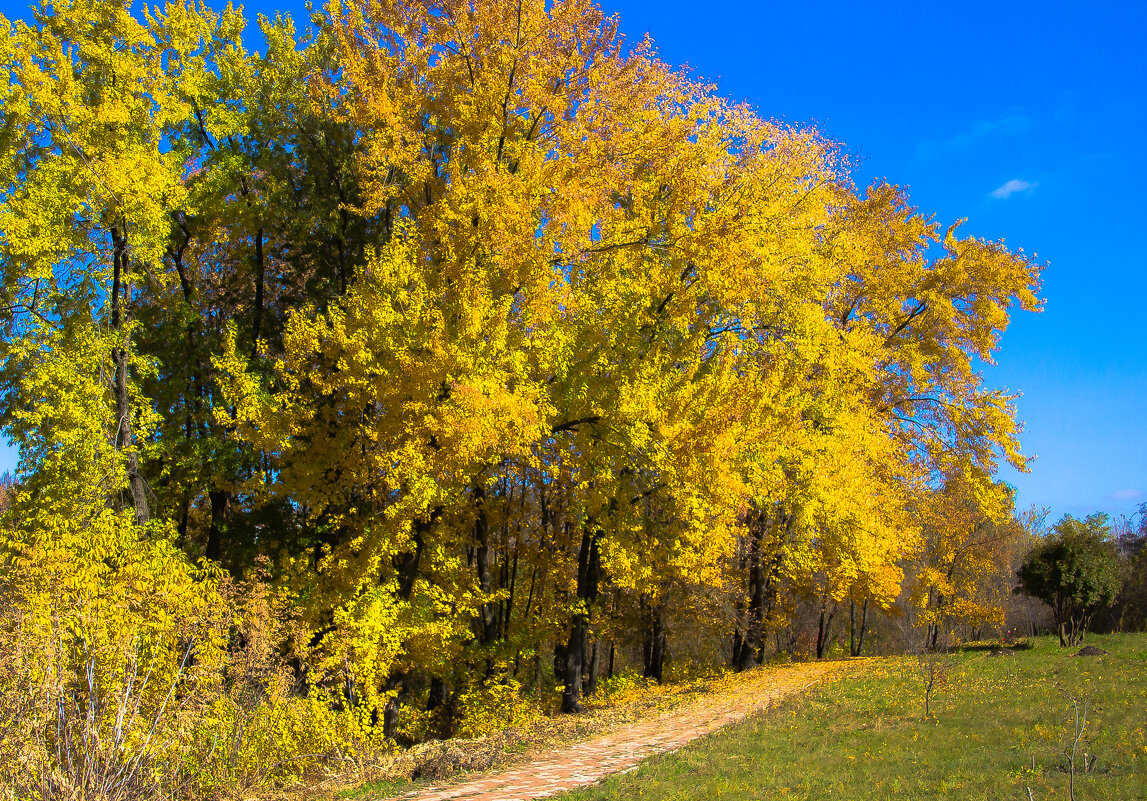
[383,662,858,801]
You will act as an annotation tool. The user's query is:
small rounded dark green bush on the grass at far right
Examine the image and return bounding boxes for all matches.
[1019,514,1121,645]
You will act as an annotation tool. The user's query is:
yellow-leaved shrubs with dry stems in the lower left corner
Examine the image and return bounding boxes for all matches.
[0,501,379,801]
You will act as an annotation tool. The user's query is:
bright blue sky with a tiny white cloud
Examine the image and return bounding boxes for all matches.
[0,0,1147,520]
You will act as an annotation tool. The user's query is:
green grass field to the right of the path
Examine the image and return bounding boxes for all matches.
[560,635,1147,801]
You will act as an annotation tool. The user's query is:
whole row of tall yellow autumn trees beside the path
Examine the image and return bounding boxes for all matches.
[0,0,1039,784]
